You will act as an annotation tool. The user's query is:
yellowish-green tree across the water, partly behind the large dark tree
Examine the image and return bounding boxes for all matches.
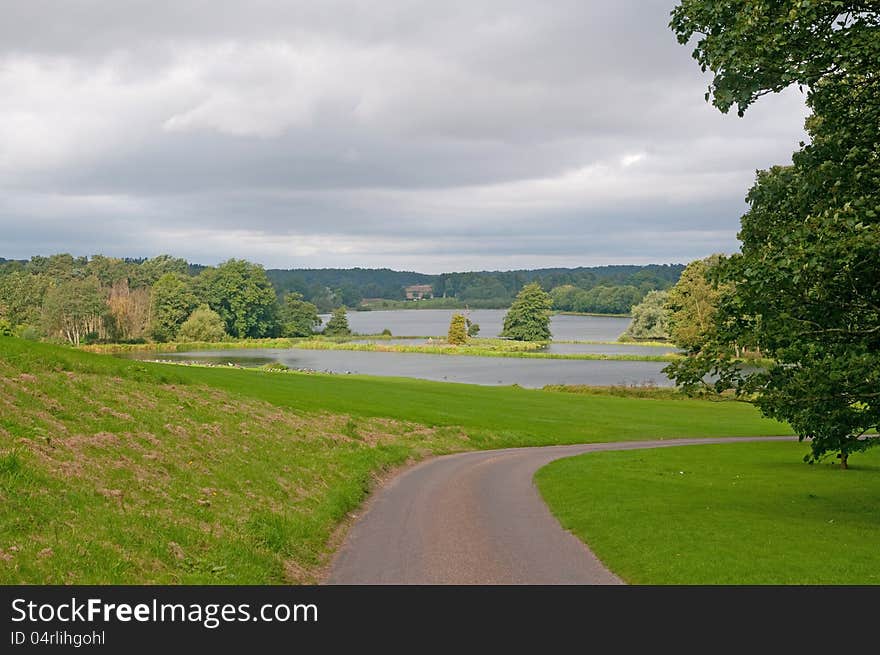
[666,255,733,352]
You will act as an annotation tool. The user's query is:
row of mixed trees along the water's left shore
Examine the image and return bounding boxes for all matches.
[0,255,321,345]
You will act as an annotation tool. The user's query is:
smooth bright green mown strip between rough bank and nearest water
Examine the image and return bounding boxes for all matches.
[174,367,791,448]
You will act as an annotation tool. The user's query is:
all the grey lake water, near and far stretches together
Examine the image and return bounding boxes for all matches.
[125,309,675,388]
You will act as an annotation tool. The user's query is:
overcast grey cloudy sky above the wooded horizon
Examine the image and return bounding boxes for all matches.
[0,0,806,273]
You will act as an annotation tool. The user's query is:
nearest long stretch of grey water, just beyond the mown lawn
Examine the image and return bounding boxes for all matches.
[129,348,672,388]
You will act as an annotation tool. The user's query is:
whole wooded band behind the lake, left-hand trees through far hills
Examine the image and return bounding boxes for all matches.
[0,254,684,344]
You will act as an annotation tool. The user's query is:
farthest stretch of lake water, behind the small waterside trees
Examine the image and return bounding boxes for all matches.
[321,309,630,341]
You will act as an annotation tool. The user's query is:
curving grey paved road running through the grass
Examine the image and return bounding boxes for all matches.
[327,437,793,584]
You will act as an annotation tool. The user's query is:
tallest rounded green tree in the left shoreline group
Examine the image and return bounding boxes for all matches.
[195,259,278,339]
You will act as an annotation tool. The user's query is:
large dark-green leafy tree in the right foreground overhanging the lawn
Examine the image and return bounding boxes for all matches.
[669,0,880,467]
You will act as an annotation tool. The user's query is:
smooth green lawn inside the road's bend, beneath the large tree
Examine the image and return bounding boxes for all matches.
[535,443,880,584]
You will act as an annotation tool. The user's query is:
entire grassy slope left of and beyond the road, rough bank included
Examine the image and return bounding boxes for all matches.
[0,337,787,584]
